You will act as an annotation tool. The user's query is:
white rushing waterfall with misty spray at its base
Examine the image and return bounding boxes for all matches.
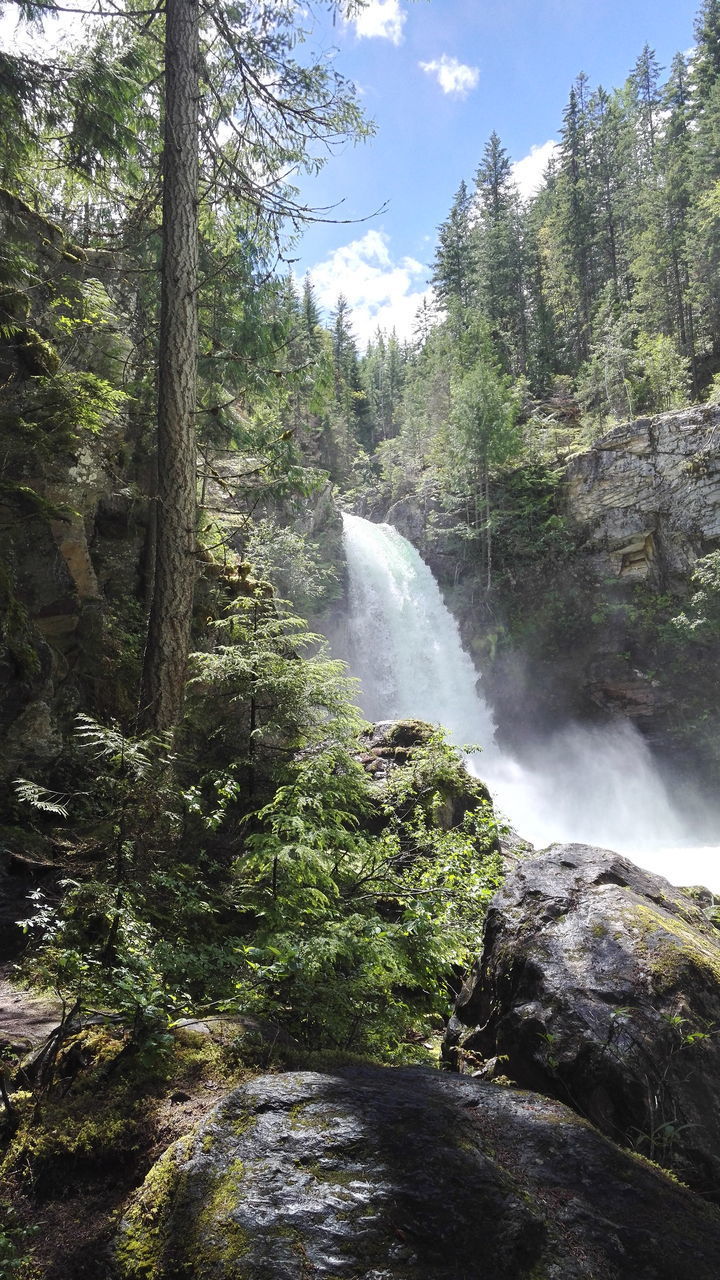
[337,515,720,891]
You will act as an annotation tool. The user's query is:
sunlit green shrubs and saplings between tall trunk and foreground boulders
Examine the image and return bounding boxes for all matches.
[14,680,501,1059]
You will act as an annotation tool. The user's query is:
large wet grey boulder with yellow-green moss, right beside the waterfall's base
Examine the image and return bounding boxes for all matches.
[447,845,720,1201]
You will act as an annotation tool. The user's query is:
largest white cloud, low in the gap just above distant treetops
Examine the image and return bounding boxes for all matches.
[304,230,430,348]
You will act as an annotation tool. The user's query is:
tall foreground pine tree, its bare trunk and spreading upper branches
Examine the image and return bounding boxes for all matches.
[3,0,364,727]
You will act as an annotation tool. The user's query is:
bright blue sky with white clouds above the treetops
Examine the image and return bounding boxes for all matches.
[290,0,700,343]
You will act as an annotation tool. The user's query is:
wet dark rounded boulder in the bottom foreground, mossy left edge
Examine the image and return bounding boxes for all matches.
[114,1068,720,1280]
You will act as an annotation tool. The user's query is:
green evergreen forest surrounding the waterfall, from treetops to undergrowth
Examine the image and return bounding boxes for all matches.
[0,0,720,1280]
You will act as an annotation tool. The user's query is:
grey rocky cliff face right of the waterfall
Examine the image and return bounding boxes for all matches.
[386,406,720,767]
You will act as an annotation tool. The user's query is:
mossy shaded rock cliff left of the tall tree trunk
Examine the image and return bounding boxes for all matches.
[0,191,147,781]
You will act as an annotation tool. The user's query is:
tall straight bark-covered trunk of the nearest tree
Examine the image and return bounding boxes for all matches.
[141,0,200,728]
